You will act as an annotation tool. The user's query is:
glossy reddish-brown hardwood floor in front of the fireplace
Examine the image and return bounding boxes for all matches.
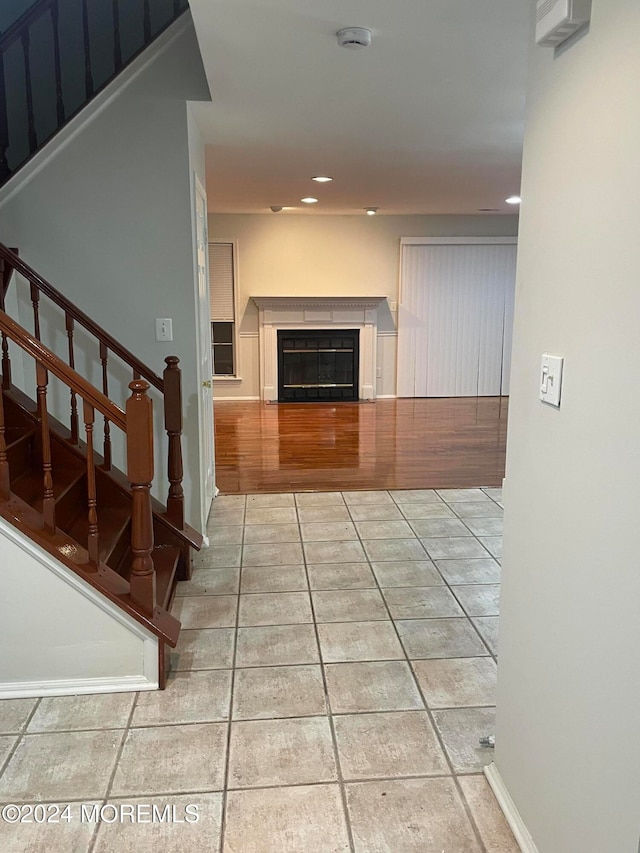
[214,397,508,494]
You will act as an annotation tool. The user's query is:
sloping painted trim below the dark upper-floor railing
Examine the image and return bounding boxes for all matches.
[0,15,192,208]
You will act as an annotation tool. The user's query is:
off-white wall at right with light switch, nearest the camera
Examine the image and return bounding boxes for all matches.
[496,0,640,853]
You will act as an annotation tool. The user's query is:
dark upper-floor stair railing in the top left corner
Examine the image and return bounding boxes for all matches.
[0,0,189,185]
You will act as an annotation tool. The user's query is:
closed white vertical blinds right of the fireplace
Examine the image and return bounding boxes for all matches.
[397,242,516,397]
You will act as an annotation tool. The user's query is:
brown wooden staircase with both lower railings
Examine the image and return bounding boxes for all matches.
[0,238,202,688]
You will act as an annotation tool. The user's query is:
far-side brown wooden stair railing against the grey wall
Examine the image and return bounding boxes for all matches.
[0,243,185,530]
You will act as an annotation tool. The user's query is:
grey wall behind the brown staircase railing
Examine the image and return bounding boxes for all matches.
[0,17,208,527]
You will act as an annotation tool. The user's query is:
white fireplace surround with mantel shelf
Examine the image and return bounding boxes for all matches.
[251,296,387,401]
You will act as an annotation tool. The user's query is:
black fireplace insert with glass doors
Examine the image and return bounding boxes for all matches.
[278,329,360,403]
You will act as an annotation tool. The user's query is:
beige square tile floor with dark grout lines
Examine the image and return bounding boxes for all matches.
[0,489,518,853]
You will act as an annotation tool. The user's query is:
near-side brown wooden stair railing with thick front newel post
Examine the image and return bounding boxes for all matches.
[0,311,156,616]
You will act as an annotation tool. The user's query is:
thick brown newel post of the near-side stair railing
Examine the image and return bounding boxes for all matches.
[126,379,156,614]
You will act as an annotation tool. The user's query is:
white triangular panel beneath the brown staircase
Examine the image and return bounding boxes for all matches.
[0,518,160,699]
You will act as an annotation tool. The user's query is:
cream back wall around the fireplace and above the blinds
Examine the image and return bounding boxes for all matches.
[209,213,518,399]
